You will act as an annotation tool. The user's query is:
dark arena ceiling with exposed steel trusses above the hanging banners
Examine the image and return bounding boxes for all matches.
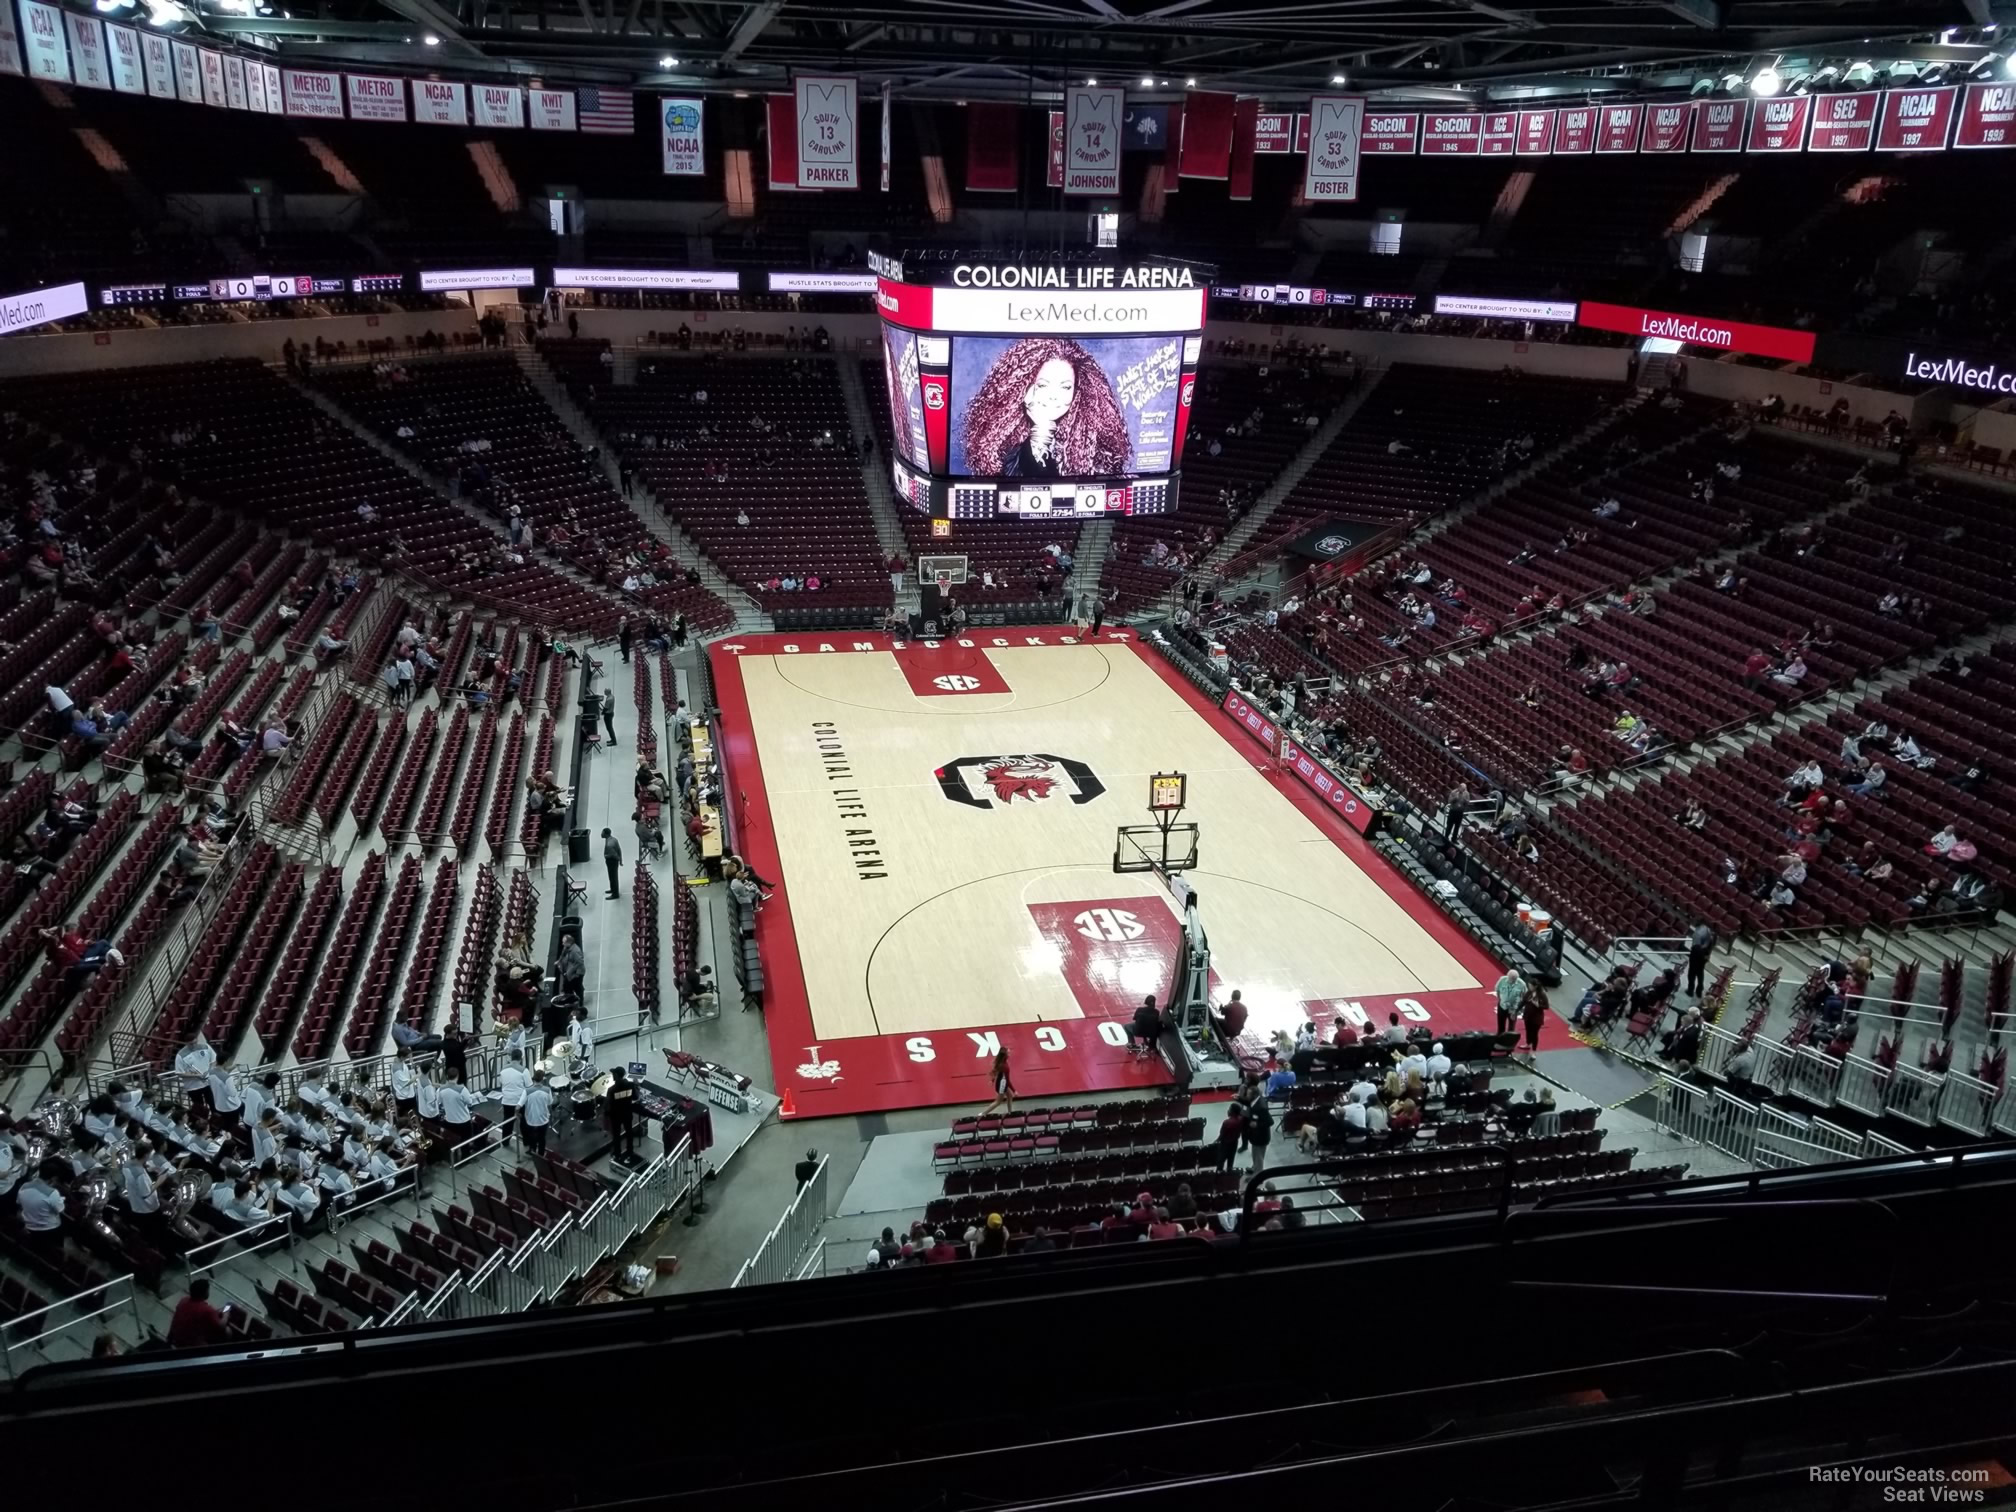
[196,0,1991,103]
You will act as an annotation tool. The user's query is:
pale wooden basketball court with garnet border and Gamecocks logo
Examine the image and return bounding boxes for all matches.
[712,627,1540,1117]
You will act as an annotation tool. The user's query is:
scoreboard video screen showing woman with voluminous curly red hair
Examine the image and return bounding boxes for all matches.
[943,337,1183,480]
